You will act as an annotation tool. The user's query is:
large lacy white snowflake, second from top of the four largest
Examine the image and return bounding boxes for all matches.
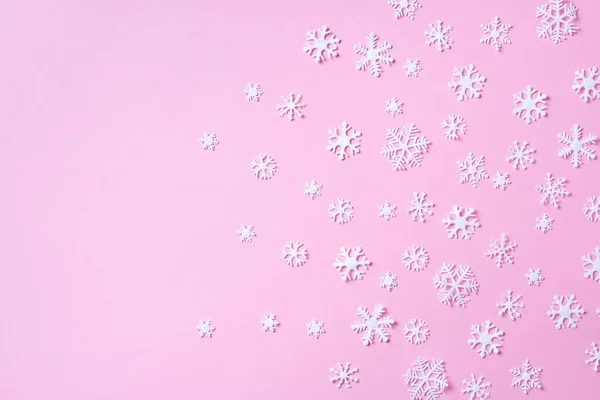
[381,124,431,171]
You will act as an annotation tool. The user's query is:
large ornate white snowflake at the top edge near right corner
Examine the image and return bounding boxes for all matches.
[535,0,579,44]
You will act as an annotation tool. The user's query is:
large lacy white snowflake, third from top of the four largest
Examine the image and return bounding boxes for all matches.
[433,263,479,307]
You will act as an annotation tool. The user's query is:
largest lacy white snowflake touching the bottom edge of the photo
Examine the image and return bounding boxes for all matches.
[403,357,448,400]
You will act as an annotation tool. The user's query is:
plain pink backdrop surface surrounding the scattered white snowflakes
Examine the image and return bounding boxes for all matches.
[0,0,600,400]
